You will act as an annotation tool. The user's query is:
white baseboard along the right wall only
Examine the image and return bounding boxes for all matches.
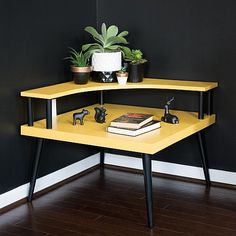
[105,153,236,185]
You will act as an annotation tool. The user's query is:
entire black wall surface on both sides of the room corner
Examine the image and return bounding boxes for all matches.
[0,0,236,193]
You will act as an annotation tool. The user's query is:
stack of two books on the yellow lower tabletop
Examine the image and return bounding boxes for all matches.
[107,113,161,136]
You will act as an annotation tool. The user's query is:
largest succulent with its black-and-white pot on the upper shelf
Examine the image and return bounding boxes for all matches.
[82,23,128,82]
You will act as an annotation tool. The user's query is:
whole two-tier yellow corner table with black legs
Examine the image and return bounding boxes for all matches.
[21,78,218,228]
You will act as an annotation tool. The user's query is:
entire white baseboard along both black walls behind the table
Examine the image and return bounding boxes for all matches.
[0,153,236,209]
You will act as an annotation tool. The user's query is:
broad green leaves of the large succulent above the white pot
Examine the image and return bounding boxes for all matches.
[82,23,129,57]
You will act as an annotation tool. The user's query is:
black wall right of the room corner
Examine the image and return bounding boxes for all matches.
[98,0,236,171]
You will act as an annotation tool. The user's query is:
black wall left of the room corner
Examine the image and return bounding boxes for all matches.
[0,0,96,194]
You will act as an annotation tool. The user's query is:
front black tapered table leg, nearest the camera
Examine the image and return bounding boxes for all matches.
[142,154,154,228]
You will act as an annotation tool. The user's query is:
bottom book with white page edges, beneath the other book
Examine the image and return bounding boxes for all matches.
[107,120,161,136]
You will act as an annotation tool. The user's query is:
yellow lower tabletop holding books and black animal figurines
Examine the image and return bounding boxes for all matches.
[21,104,215,154]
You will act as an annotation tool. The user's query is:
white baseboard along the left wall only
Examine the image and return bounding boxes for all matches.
[0,154,100,209]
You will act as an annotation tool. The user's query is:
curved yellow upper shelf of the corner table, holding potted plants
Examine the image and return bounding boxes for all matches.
[21,78,218,99]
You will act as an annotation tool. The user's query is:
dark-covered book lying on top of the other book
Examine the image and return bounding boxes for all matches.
[110,113,153,129]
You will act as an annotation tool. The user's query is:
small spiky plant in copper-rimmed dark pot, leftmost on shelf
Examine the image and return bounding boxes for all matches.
[65,48,92,84]
